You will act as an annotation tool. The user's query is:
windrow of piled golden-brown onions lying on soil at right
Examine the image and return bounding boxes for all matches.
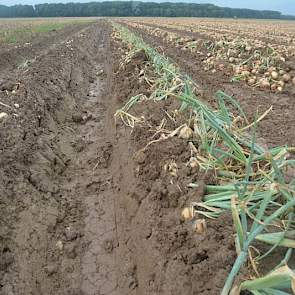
[122,21,295,93]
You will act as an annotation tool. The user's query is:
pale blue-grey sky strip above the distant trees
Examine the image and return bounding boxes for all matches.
[0,0,295,15]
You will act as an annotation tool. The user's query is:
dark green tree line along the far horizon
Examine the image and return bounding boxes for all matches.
[0,1,295,19]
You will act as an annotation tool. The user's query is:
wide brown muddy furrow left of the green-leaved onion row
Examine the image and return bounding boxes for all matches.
[0,21,169,295]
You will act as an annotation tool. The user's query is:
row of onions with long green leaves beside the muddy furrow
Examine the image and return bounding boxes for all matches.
[114,24,295,294]
